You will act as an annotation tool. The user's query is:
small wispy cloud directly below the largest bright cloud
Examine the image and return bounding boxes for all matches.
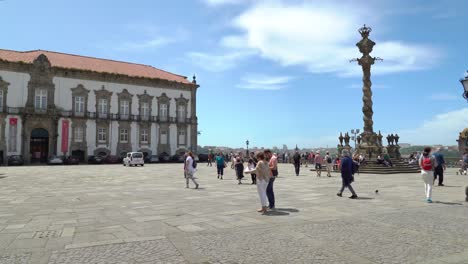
[237,75,292,90]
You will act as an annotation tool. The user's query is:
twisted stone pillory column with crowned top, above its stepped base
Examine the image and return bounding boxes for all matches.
[351,25,382,148]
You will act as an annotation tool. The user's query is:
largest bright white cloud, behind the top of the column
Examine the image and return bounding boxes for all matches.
[221,1,440,76]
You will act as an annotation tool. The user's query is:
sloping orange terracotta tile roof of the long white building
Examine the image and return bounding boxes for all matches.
[0,49,192,84]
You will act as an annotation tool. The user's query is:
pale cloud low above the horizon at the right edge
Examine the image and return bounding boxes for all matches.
[398,107,468,145]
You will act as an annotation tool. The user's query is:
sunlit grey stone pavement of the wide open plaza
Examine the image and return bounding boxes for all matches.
[0,163,468,264]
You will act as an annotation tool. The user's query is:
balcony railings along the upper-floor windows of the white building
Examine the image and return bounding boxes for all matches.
[4,107,192,124]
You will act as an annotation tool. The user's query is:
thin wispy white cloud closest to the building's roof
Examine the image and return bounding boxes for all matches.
[187,51,252,72]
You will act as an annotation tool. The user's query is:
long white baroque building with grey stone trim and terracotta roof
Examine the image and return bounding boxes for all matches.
[0,50,199,163]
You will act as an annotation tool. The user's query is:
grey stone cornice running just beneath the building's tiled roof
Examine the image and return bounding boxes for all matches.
[0,59,200,91]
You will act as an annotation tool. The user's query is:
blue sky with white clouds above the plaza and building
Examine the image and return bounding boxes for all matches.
[0,0,468,148]
